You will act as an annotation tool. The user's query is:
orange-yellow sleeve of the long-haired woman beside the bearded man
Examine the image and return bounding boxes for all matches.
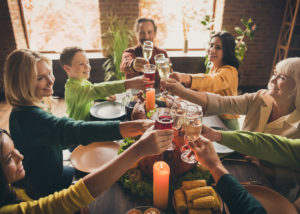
[191,65,238,93]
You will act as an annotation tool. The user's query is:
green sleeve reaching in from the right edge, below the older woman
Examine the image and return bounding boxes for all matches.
[219,131,300,170]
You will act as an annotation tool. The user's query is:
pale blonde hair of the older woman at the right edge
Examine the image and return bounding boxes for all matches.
[275,57,300,111]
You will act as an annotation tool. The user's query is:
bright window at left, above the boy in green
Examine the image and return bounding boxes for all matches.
[21,0,101,52]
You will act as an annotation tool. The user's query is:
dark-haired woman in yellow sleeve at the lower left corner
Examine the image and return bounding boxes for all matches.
[0,128,173,214]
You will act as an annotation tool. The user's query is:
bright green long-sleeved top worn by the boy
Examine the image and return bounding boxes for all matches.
[65,78,125,120]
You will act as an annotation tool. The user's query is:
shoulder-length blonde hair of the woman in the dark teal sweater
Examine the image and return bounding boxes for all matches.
[3,49,52,109]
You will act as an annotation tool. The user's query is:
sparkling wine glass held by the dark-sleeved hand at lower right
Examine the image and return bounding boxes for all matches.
[181,105,203,164]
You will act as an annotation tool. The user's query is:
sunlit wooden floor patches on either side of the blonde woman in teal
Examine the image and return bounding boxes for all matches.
[0,98,66,131]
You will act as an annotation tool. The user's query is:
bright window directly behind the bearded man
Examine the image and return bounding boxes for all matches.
[140,0,214,50]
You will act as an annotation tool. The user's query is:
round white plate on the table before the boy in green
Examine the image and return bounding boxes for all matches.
[90,102,125,119]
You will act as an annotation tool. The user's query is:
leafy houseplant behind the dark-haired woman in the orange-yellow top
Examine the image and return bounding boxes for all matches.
[201,15,256,73]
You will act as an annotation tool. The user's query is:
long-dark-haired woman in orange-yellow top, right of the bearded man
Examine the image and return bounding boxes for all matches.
[170,32,239,130]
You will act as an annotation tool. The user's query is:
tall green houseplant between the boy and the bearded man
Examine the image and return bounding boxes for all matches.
[103,13,134,81]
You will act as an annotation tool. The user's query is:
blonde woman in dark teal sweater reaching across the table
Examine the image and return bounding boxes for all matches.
[4,49,156,197]
